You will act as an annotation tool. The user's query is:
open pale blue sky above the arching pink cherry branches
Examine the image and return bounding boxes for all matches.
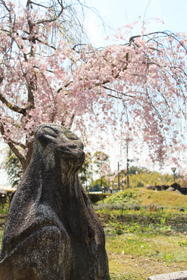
[85,0,187,46]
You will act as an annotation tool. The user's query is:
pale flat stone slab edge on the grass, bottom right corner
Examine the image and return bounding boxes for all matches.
[148,270,187,280]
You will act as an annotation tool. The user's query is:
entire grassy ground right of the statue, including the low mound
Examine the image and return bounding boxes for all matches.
[97,188,187,280]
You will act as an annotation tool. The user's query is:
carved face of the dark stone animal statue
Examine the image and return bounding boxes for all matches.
[35,124,84,164]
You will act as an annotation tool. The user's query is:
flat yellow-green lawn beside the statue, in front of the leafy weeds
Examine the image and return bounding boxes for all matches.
[106,233,187,280]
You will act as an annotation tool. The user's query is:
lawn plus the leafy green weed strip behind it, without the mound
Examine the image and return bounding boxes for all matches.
[105,215,187,280]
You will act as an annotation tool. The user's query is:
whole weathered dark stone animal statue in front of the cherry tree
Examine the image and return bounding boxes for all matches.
[0,124,109,280]
